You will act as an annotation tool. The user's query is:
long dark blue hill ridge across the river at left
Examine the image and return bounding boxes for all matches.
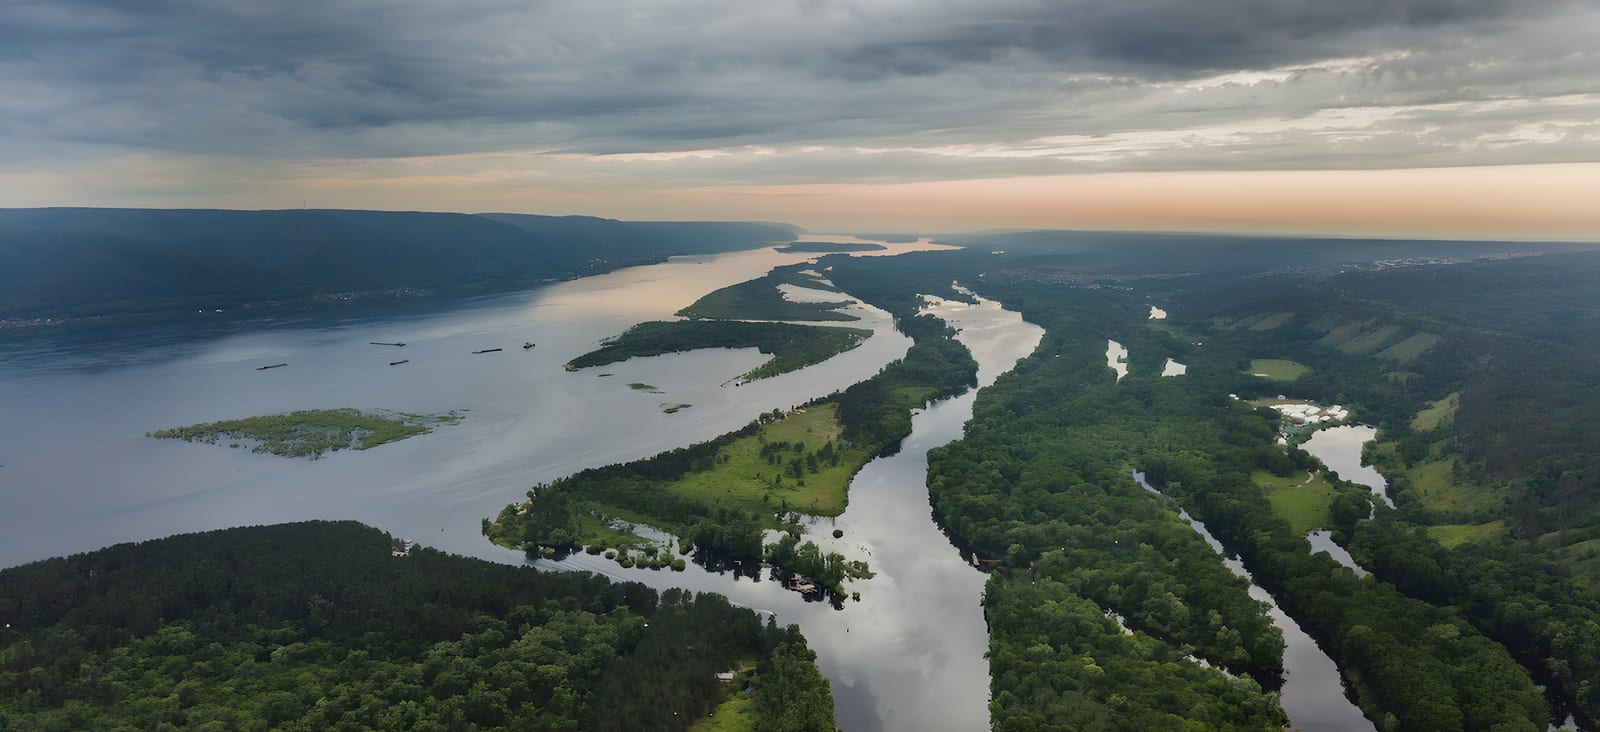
[0,208,797,320]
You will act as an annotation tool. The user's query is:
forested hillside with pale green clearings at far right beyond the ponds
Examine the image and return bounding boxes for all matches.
[1179,253,1600,722]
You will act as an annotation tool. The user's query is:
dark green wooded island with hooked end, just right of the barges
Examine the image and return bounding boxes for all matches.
[566,320,872,383]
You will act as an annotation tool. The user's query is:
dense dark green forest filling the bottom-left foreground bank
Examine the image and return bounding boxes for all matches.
[0,521,834,732]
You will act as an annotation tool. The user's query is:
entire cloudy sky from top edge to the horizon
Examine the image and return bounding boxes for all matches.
[0,0,1600,240]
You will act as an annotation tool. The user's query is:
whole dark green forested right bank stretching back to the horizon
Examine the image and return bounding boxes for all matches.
[864,241,1600,730]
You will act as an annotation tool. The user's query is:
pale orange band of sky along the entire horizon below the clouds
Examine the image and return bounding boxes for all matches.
[0,163,1600,241]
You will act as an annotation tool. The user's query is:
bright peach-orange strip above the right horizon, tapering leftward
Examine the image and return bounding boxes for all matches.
[627,163,1600,241]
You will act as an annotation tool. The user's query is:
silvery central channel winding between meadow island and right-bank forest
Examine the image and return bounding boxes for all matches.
[544,289,1043,732]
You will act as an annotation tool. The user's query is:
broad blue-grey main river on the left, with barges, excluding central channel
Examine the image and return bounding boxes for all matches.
[0,245,947,566]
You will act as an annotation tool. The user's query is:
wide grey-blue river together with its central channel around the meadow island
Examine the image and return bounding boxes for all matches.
[0,237,1042,732]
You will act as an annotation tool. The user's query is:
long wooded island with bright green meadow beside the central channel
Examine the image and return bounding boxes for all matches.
[483,286,976,596]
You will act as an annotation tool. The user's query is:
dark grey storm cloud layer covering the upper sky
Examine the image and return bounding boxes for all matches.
[0,0,1600,177]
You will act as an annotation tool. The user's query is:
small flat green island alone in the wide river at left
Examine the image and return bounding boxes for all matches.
[146,408,462,460]
